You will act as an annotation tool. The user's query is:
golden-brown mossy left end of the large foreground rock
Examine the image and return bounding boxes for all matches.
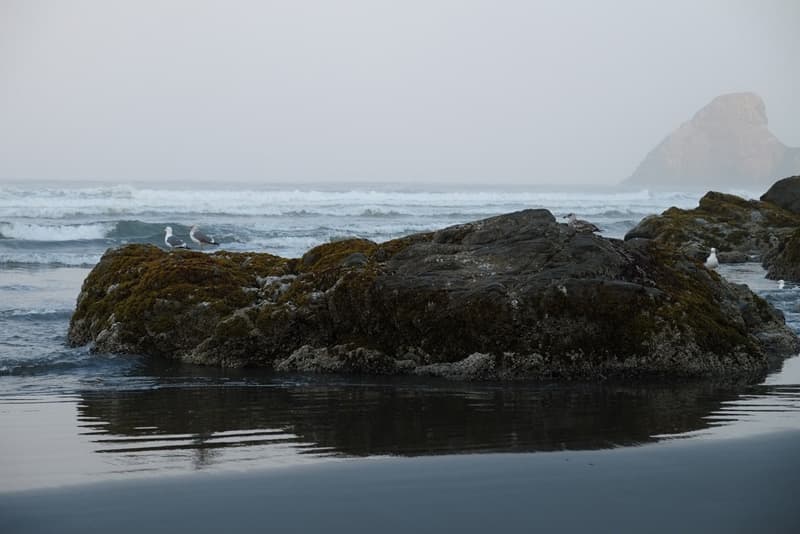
[69,245,288,354]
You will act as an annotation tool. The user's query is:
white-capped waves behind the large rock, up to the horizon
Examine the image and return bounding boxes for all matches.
[0,186,712,266]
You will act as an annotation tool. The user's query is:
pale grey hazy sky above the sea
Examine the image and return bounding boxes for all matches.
[0,0,800,185]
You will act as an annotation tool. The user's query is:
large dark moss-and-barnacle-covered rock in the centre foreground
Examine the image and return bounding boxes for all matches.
[69,210,797,379]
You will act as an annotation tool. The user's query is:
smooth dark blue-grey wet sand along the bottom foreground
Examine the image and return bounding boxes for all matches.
[0,431,800,534]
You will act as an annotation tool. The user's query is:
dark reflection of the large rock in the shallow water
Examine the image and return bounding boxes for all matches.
[78,372,752,467]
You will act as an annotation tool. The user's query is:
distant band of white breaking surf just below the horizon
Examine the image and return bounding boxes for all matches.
[0,186,708,219]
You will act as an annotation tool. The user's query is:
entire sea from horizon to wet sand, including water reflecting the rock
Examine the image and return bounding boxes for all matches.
[0,184,800,532]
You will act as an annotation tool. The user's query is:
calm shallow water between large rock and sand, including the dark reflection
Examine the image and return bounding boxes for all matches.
[0,356,800,492]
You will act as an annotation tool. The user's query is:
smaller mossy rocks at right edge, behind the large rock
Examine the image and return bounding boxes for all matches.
[625,178,800,281]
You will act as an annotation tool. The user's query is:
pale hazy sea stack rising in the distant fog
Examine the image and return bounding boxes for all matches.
[624,93,800,191]
